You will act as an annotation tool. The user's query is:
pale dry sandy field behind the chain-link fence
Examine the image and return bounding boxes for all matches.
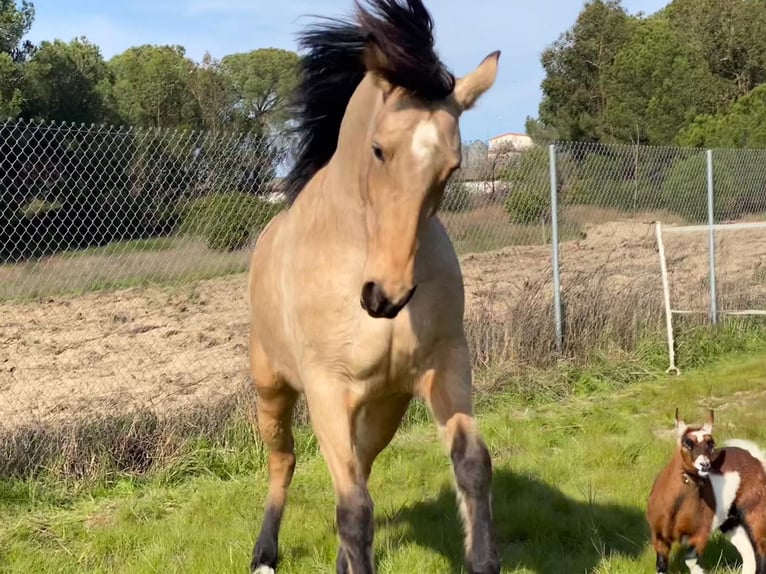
[0,207,766,427]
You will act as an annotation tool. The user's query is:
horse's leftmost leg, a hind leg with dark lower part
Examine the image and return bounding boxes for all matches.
[250,343,298,574]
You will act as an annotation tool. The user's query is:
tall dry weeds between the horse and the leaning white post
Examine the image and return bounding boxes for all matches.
[466,269,664,374]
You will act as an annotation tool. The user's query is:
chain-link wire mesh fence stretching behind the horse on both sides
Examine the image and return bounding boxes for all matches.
[0,117,766,440]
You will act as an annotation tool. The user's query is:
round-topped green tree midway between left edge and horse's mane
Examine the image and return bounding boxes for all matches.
[109,45,202,128]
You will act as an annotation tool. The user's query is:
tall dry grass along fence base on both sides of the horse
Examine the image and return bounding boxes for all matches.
[0,266,766,482]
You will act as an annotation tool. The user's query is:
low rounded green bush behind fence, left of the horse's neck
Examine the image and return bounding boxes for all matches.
[181,193,282,251]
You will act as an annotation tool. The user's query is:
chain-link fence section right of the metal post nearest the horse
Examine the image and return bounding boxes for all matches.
[555,142,766,364]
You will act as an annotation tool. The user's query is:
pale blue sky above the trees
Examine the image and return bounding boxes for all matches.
[22,0,669,141]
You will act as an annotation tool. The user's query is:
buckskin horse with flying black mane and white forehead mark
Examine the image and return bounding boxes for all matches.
[248,0,500,574]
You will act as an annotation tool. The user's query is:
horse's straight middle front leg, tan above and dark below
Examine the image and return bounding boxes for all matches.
[305,377,375,574]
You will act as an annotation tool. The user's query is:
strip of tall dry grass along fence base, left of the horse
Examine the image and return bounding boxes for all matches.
[0,388,255,483]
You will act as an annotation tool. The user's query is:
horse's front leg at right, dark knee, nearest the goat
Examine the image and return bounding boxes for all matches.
[418,338,500,574]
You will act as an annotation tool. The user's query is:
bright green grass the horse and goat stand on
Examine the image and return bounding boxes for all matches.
[0,347,766,574]
